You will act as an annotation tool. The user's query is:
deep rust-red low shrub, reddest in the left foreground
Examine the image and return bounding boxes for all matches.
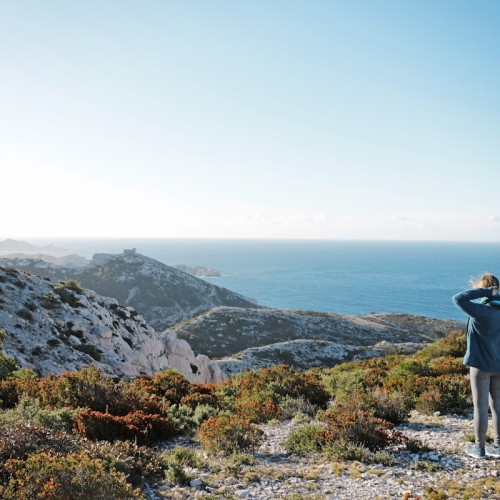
[75,410,175,444]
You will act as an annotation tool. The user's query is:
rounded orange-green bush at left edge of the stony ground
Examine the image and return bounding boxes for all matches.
[197,415,264,455]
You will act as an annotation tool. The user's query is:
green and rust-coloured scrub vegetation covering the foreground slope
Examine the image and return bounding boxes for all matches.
[0,331,471,499]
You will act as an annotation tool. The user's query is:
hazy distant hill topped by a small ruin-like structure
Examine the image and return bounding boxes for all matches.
[0,250,255,331]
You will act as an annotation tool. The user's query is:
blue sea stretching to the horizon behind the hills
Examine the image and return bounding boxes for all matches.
[24,239,500,321]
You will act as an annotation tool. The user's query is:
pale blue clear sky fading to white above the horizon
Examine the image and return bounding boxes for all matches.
[0,0,500,241]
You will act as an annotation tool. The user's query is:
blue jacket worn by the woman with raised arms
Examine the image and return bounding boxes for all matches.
[452,288,500,373]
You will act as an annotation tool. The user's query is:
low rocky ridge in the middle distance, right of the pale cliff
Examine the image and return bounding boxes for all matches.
[167,307,464,374]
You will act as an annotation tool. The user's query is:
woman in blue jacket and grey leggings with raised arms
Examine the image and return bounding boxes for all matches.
[453,273,500,458]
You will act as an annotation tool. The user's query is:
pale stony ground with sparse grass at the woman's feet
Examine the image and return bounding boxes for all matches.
[152,413,500,500]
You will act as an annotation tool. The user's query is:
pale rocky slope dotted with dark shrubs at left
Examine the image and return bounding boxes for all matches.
[0,267,222,382]
